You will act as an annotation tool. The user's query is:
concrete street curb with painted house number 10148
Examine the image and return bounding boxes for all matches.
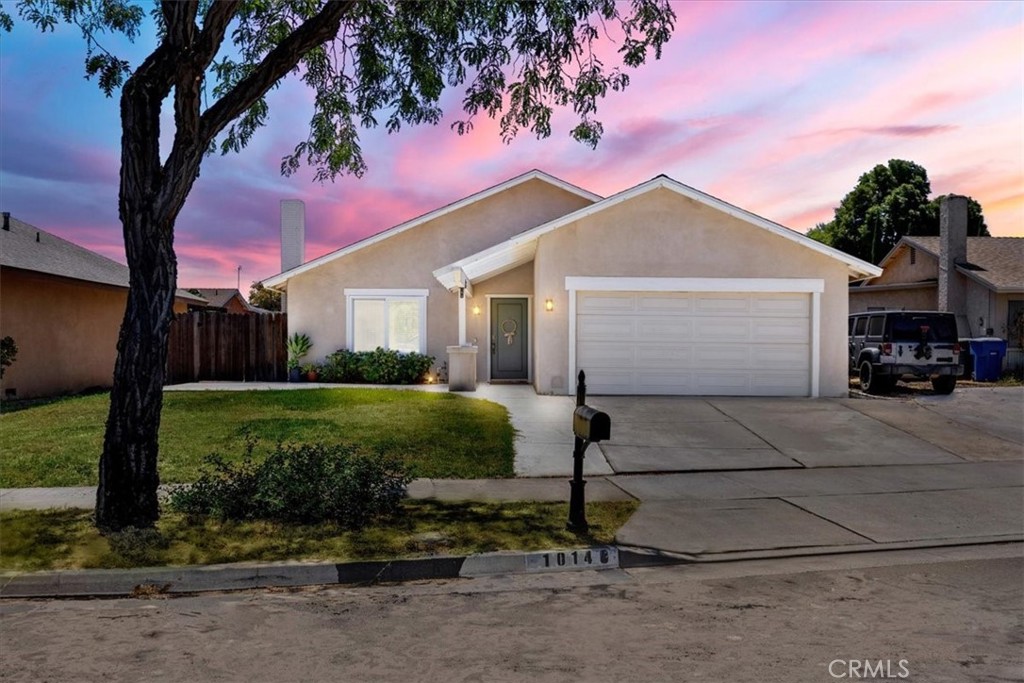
[0,546,632,599]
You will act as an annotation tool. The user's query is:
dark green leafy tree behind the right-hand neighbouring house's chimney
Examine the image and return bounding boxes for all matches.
[807,159,988,264]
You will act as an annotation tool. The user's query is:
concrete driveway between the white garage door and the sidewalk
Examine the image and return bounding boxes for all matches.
[588,387,1024,474]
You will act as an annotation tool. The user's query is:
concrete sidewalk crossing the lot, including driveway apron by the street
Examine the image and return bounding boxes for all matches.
[0,462,1024,561]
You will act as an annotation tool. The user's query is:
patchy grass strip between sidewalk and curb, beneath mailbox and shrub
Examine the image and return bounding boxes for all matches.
[0,501,638,571]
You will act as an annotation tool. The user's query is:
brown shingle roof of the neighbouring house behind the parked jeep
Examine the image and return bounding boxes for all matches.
[880,236,1024,293]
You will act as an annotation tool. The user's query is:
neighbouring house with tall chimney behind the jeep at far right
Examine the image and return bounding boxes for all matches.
[850,197,1024,362]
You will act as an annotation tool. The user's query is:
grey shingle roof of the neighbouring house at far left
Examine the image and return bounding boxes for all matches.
[0,216,204,301]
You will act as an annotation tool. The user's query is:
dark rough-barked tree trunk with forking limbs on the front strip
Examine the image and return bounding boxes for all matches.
[96,0,354,531]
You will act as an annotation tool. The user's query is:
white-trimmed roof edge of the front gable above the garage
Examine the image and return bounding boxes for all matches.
[433,175,882,289]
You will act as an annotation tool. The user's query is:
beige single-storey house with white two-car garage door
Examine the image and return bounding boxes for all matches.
[263,171,881,396]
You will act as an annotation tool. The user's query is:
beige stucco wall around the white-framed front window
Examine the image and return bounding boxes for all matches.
[287,179,590,368]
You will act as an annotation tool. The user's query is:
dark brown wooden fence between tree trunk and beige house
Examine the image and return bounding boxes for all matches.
[167,311,288,384]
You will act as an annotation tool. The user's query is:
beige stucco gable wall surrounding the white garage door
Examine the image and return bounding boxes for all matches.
[534,189,848,396]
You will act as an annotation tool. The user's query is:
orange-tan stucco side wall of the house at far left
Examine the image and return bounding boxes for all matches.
[0,268,195,398]
